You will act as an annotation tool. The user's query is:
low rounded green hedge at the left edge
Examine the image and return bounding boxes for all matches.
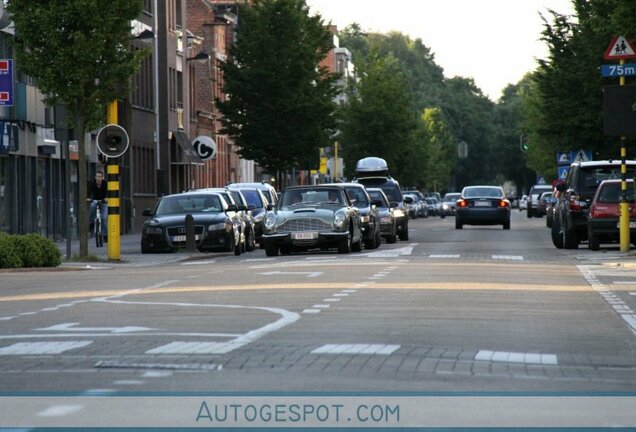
[0,232,62,268]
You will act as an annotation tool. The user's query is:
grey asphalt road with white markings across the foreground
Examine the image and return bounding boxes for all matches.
[0,211,636,426]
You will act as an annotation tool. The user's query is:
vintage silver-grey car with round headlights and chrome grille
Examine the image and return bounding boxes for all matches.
[263,185,362,256]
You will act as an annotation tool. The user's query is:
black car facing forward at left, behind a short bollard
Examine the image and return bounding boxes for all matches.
[141,192,241,255]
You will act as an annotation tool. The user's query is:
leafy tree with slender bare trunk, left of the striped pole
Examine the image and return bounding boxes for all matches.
[7,0,145,256]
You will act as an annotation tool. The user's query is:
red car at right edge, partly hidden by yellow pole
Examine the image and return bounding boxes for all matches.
[587,180,636,250]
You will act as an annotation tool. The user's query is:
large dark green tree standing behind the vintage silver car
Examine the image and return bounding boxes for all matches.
[217,0,337,179]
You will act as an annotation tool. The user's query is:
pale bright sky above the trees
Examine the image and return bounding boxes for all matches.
[306,0,573,101]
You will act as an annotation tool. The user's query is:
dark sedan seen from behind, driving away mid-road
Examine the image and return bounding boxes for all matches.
[455,186,510,229]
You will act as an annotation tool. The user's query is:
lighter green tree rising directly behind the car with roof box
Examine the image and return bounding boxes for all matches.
[340,55,425,185]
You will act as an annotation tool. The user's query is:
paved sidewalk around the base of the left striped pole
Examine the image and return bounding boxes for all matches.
[56,233,202,267]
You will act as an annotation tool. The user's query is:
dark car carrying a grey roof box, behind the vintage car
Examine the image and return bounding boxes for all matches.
[354,157,412,241]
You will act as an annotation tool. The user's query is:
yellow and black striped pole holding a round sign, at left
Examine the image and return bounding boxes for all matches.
[106,101,121,261]
